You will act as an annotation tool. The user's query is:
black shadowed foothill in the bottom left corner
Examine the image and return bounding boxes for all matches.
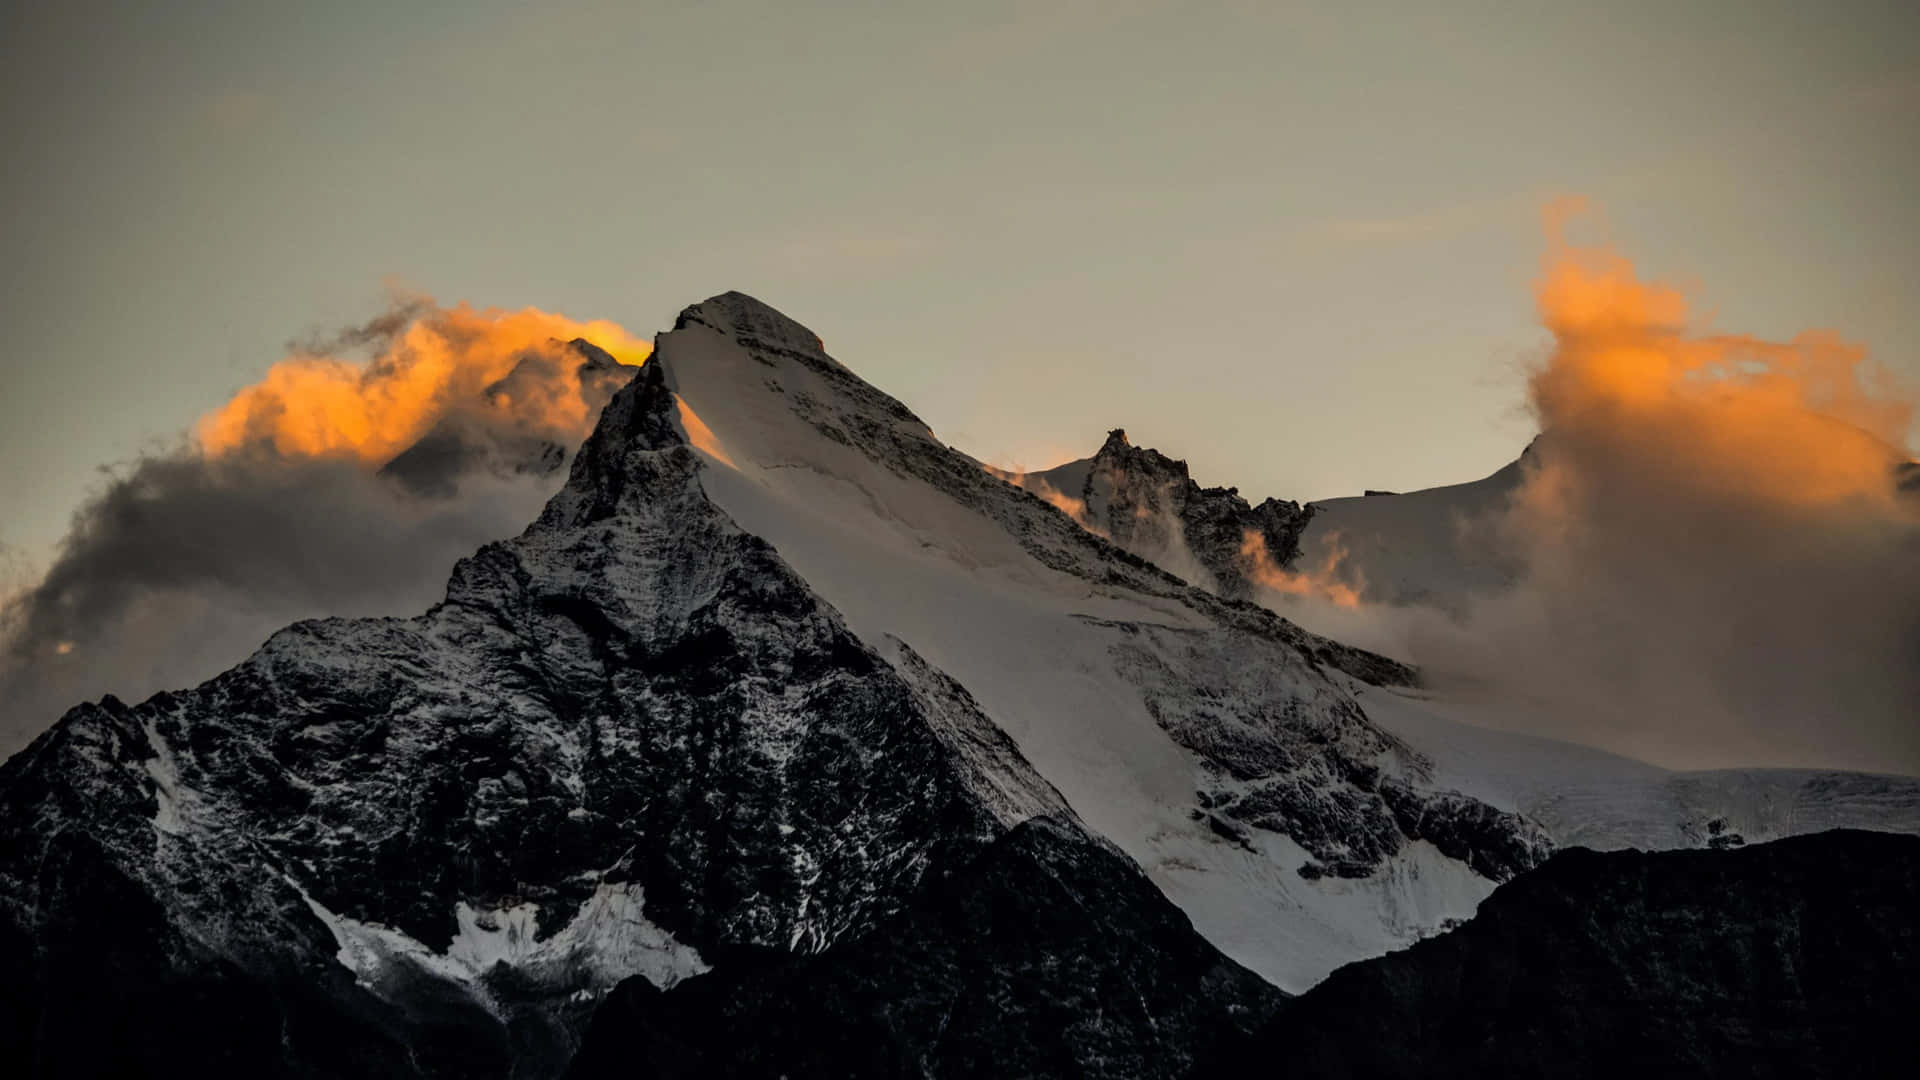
[0,830,456,1078]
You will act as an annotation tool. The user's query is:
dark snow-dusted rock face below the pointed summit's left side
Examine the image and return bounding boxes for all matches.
[0,355,1069,1076]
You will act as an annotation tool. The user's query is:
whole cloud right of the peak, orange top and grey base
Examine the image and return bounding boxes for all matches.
[1274,204,1920,773]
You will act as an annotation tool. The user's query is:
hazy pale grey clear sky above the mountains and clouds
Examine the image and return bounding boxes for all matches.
[0,2,1920,565]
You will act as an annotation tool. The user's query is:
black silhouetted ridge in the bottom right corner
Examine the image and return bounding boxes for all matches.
[1196,832,1920,1080]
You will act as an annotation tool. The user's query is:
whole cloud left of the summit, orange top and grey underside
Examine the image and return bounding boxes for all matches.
[0,298,647,751]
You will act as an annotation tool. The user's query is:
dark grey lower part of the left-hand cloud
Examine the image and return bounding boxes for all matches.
[0,454,555,751]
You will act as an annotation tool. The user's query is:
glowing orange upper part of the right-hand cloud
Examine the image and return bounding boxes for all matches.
[1530,200,1914,518]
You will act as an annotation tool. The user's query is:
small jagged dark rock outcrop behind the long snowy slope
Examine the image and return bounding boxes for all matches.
[1068,429,1313,600]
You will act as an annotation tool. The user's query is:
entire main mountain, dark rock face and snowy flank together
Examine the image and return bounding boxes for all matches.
[0,294,1920,1076]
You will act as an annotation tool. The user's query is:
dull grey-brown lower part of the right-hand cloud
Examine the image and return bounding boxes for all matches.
[1409,446,1920,773]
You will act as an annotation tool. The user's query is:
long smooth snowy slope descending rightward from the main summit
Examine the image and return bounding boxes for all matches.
[655,294,1544,990]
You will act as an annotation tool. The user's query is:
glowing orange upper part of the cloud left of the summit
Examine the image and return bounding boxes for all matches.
[196,302,651,463]
